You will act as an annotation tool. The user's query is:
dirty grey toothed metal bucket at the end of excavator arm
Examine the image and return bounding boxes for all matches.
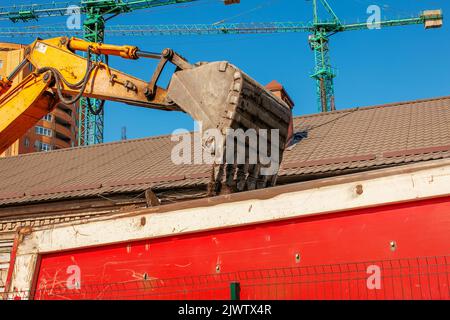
[167,62,292,194]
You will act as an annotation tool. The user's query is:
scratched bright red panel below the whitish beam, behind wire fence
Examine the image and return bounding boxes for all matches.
[34,198,450,299]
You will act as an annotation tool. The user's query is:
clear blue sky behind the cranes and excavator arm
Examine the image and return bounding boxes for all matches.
[0,0,450,142]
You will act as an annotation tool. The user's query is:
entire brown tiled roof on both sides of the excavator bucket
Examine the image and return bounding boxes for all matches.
[0,97,450,206]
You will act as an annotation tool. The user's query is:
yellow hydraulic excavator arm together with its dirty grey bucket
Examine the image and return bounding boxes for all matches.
[0,37,291,193]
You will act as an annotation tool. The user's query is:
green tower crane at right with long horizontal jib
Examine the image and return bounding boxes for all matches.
[0,0,443,112]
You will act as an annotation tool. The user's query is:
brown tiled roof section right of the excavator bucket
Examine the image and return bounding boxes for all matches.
[282,97,450,175]
